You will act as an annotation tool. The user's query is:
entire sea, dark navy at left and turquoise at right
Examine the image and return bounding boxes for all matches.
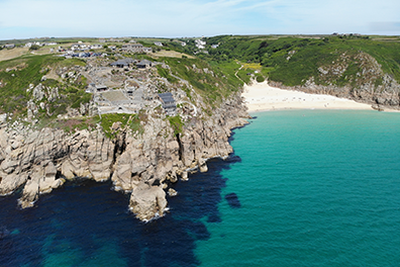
[0,110,400,266]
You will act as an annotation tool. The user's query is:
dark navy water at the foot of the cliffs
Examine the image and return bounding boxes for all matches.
[0,156,240,267]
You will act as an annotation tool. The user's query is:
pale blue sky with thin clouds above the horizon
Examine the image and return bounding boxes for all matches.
[0,0,400,40]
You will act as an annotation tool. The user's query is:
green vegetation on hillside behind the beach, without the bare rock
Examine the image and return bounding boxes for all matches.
[206,36,400,86]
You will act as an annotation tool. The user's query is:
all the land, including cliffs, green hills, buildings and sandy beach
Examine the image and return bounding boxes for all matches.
[0,35,400,221]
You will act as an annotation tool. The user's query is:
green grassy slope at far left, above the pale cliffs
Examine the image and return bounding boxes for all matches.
[0,55,91,117]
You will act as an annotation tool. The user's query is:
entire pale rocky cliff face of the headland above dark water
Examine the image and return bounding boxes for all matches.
[0,95,248,220]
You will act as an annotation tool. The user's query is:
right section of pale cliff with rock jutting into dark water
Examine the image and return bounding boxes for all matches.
[111,93,248,220]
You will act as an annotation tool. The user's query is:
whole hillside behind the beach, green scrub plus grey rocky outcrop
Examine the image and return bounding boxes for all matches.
[203,35,400,106]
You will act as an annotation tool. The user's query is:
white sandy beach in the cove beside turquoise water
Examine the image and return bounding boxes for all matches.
[242,81,372,112]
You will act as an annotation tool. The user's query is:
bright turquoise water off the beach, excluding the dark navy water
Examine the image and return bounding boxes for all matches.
[196,110,400,267]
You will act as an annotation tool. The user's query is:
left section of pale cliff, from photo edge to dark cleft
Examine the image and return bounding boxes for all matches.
[0,123,115,208]
